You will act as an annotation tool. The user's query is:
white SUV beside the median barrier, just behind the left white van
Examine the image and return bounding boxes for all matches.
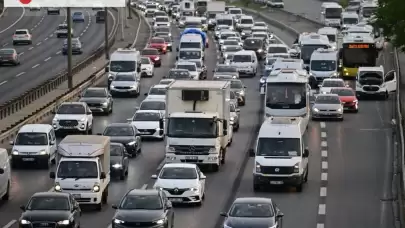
[52,102,93,134]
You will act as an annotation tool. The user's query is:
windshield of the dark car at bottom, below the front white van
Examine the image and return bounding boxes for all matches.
[229,203,274,218]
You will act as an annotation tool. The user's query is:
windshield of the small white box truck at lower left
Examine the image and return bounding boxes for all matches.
[57,161,98,179]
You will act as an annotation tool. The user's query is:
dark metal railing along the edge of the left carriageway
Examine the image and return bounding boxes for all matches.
[0,8,118,120]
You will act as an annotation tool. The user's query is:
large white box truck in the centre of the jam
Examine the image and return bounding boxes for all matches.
[165,80,232,171]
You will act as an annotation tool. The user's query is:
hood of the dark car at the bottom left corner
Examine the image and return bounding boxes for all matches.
[21,210,70,222]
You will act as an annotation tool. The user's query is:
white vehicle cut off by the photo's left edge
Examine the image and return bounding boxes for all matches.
[0,148,11,200]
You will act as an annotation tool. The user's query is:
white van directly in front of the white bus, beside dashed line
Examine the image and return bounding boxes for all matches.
[249,117,309,192]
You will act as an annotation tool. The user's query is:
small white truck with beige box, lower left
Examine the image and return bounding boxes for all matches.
[50,135,110,210]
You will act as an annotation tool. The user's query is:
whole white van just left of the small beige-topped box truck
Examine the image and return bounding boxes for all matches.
[10,124,56,168]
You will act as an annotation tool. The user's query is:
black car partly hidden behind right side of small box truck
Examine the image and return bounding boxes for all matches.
[110,143,129,180]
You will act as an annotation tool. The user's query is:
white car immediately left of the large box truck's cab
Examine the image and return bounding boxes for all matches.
[128,110,164,140]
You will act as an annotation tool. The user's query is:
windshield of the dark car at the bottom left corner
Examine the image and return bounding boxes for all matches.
[26,196,70,211]
